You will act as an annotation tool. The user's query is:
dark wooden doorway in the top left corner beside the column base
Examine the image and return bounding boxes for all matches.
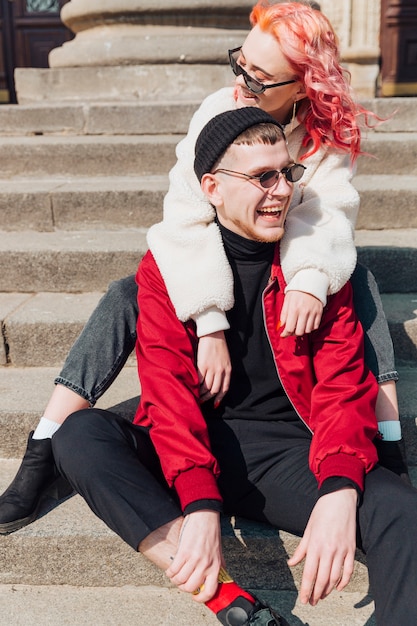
[0,0,73,103]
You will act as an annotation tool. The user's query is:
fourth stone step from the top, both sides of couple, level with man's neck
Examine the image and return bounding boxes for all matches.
[0,228,417,292]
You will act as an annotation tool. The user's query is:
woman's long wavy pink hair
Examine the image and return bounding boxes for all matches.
[250,0,379,163]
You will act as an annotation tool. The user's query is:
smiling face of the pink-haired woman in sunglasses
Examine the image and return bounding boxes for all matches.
[235,26,305,124]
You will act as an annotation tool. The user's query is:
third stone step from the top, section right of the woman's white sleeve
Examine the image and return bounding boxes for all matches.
[353,174,417,230]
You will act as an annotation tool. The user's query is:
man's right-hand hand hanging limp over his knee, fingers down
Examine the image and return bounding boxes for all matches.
[288,488,358,606]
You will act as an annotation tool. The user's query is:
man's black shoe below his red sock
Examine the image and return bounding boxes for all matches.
[217,597,289,626]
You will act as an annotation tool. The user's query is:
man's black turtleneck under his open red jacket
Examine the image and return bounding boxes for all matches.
[204,224,299,421]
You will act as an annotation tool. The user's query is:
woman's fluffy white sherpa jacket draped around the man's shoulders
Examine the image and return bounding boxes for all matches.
[148,87,359,336]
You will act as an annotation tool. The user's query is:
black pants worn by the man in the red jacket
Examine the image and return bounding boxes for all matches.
[52,409,417,626]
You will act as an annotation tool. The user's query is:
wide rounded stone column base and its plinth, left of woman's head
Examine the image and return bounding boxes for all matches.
[16,0,253,103]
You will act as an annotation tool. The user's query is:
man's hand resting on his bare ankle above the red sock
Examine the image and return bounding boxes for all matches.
[165,510,224,602]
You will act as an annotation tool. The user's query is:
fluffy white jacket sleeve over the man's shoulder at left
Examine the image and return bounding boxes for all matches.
[148,88,235,336]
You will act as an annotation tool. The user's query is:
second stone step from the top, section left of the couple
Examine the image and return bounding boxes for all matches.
[0,134,181,178]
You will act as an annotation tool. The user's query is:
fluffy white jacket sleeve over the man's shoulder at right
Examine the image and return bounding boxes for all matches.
[281,126,359,304]
